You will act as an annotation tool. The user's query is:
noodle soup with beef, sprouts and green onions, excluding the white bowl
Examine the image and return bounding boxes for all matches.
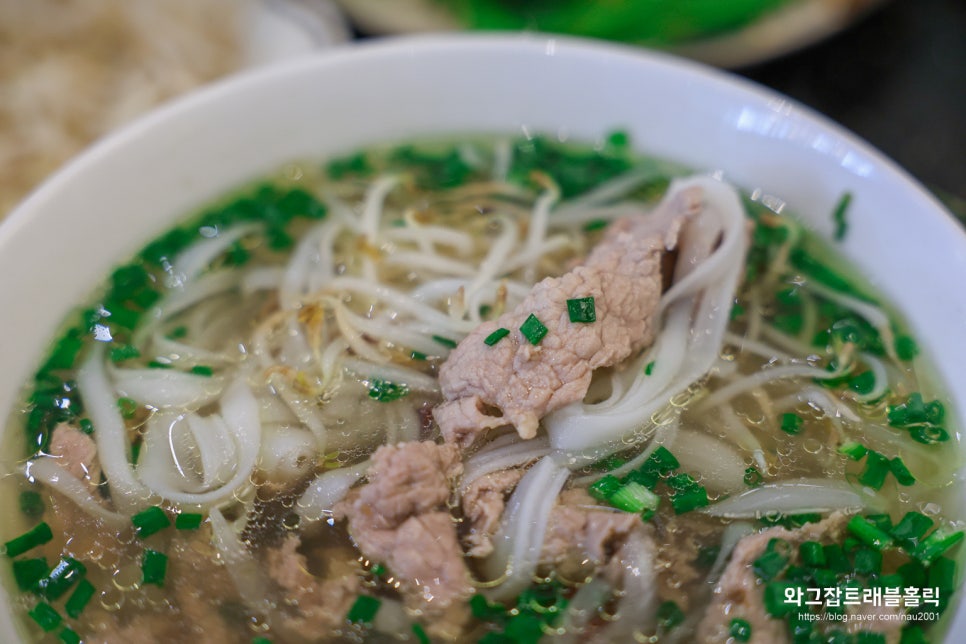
[4,133,963,644]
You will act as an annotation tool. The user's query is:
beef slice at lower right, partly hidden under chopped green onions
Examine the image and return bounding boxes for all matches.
[697,512,903,644]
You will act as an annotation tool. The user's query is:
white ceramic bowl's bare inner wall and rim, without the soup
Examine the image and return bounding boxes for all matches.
[0,36,966,642]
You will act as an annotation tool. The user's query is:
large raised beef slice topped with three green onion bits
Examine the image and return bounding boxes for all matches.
[433,188,702,446]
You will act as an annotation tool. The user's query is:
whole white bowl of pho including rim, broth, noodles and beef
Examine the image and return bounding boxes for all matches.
[0,35,966,644]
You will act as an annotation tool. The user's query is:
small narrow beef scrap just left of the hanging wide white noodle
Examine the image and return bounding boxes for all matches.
[461,468,525,557]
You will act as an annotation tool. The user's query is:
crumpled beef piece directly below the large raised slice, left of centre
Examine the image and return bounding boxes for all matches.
[335,442,472,614]
